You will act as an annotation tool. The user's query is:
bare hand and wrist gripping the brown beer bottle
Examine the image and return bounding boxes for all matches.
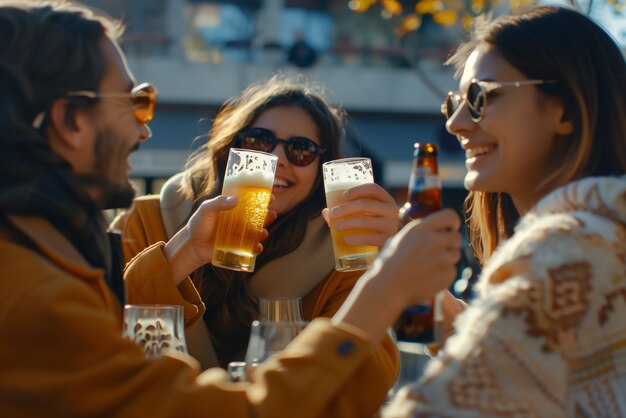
[333,209,461,346]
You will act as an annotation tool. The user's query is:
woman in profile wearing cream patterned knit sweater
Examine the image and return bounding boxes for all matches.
[384,7,626,417]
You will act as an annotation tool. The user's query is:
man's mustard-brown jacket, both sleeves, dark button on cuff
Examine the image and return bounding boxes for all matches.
[0,217,384,418]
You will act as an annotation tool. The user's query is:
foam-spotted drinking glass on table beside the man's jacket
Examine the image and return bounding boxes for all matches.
[122,305,187,356]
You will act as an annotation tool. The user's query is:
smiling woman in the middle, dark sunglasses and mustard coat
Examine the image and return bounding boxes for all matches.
[114,75,398,399]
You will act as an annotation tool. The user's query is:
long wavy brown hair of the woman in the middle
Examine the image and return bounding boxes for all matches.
[177,75,345,334]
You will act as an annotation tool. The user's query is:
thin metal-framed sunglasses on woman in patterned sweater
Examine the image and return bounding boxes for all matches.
[441,79,557,123]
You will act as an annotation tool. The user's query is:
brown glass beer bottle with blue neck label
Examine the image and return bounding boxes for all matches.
[396,143,443,343]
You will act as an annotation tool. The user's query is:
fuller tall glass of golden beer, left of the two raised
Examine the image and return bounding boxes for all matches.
[211,148,278,272]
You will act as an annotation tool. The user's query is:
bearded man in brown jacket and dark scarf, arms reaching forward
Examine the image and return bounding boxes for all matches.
[0,0,460,417]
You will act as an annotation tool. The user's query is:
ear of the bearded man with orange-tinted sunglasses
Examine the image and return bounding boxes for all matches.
[48,98,87,149]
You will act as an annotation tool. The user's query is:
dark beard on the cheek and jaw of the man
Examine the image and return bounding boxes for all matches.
[78,129,139,210]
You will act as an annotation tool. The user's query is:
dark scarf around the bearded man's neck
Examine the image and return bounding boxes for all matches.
[0,131,125,303]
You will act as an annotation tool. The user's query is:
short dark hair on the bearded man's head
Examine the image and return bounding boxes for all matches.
[0,1,122,137]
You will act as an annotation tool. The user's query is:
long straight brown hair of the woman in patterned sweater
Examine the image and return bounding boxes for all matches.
[447,6,626,262]
